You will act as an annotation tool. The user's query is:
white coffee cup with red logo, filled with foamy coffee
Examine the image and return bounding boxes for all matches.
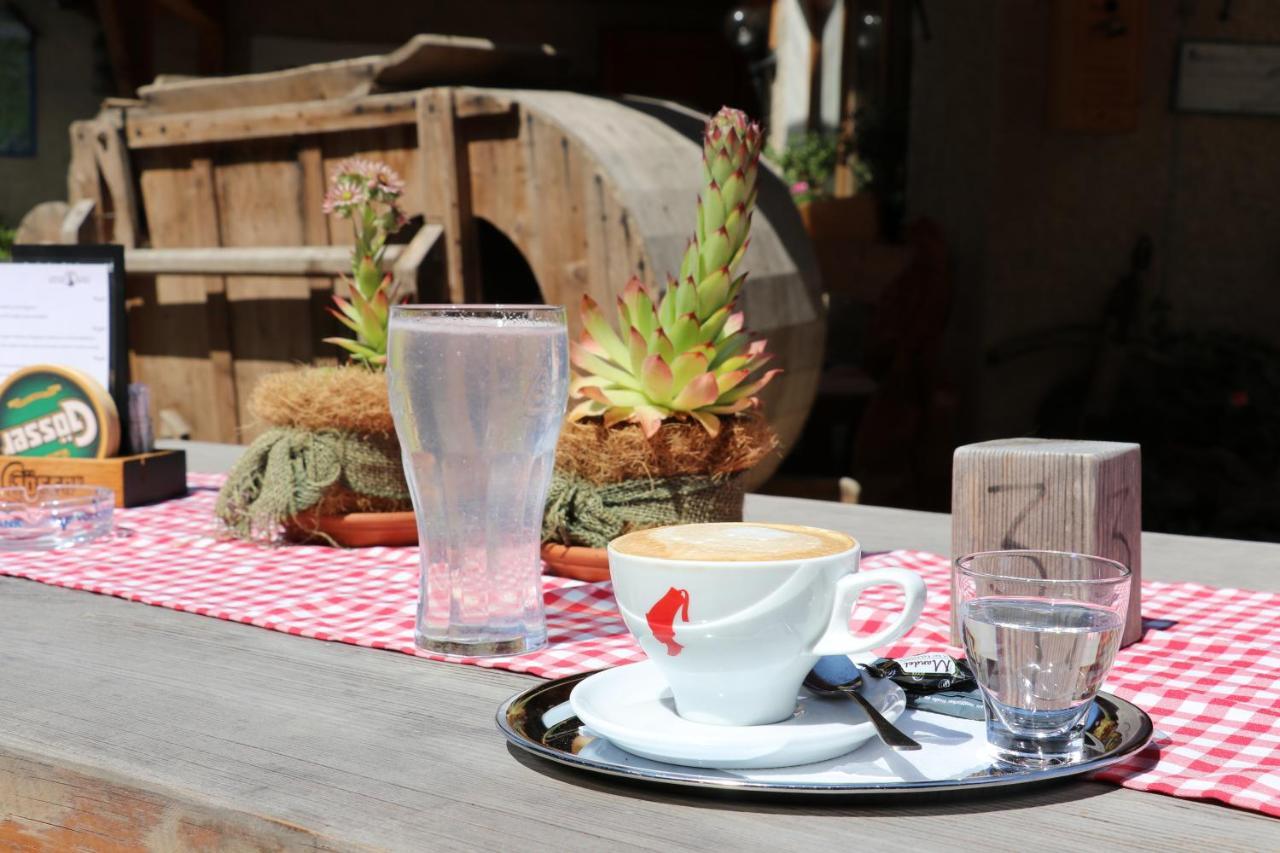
[608,523,925,726]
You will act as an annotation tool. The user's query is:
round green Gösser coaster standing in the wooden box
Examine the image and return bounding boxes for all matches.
[0,365,120,459]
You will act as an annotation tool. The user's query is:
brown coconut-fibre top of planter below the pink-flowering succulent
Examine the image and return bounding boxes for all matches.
[248,365,396,435]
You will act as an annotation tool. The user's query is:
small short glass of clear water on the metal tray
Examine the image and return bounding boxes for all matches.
[956,551,1130,767]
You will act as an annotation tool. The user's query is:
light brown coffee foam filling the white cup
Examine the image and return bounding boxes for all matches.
[611,523,856,562]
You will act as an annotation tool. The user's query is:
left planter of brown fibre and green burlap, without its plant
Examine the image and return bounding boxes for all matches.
[216,366,416,544]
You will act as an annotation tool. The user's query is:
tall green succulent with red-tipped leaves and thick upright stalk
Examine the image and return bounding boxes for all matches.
[570,108,780,437]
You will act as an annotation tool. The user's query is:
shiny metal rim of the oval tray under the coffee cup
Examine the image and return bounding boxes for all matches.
[497,672,1155,797]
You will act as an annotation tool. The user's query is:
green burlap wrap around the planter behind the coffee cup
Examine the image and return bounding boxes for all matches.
[543,470,742,548]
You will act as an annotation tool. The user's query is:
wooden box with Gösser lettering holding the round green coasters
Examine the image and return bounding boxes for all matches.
[0,451,187,507]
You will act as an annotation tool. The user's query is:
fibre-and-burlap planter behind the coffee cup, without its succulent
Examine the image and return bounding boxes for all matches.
[543,412,778,580]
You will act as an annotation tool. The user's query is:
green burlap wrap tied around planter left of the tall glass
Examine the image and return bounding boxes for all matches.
[216,427,410,539]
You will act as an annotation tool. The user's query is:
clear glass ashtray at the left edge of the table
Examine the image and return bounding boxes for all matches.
[0,485,115,551]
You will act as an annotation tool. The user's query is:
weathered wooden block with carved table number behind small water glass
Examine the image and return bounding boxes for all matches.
[951,438,1142,646]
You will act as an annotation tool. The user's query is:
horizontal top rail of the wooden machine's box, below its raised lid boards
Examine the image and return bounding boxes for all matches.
[127,93,416,149]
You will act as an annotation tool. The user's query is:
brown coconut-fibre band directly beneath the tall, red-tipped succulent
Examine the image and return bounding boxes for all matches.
[556,412,778,484]
